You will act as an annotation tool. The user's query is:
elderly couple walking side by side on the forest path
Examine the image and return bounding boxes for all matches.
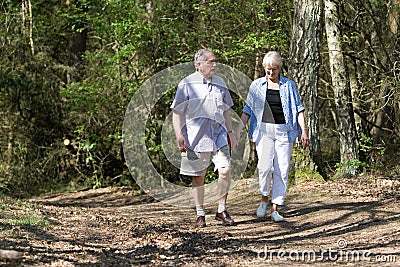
[171,49,309,228]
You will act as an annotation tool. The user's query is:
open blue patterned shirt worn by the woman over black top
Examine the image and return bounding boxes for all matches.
[243,76,305,143]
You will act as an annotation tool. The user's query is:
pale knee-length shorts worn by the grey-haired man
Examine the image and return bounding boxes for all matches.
[180,146,231,176]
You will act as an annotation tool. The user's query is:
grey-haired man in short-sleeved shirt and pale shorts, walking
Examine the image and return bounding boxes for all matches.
[171,49,237,227]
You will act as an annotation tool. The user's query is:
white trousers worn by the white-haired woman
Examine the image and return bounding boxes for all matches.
[256,123,293,205]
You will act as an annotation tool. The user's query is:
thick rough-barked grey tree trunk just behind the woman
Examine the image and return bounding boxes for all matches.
[289,0,327,179]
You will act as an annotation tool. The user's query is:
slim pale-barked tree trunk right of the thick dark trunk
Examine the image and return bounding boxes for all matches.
[325,0,358,176]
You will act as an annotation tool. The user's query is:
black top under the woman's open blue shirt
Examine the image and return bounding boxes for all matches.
[262,89,286,124]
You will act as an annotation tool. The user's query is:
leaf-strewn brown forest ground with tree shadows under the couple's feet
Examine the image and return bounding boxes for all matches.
[0,176,400,266]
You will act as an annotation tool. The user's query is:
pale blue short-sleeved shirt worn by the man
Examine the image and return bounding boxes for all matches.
[171,72,233,152]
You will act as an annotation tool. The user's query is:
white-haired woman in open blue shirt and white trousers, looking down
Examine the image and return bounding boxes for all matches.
[237,51,309,222]
